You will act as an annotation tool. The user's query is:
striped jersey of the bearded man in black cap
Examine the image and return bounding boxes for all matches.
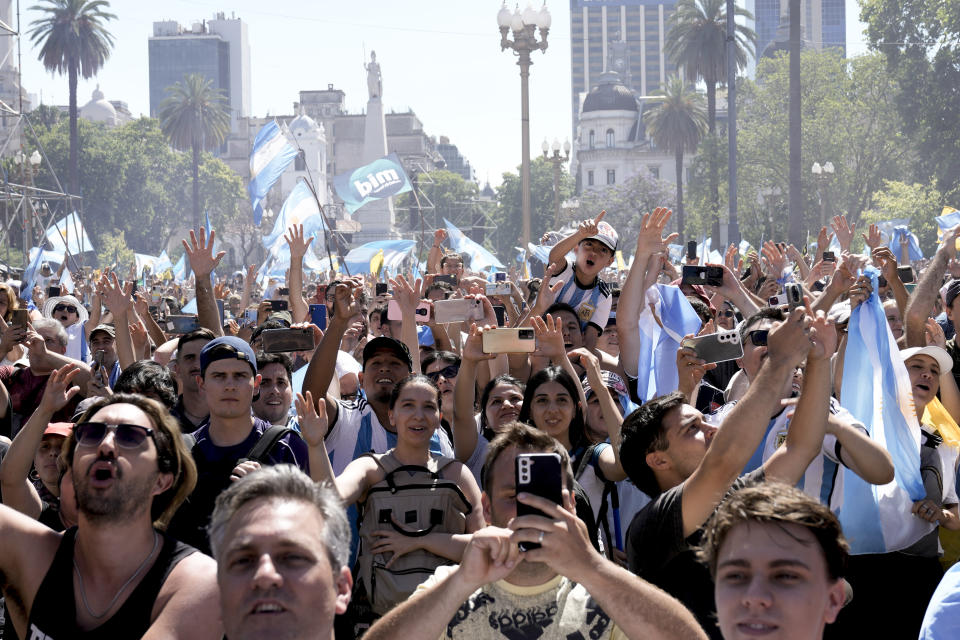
[326,397,453,475]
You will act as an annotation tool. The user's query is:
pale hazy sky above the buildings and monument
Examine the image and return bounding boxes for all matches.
[15,0,863,185]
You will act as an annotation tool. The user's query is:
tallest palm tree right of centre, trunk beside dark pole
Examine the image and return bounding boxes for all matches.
[664,0,757,246]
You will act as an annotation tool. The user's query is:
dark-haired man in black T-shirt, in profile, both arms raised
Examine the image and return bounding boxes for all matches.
[620,307,837,639]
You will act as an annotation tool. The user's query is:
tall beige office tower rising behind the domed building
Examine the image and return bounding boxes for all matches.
[570,0,676,137]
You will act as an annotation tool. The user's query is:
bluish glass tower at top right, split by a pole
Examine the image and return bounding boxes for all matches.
[754,0,847,58]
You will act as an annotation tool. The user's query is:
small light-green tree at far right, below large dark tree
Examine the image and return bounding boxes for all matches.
[863,180,944,257]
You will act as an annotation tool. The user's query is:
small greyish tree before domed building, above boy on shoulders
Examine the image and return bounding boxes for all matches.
[574,171,676,246]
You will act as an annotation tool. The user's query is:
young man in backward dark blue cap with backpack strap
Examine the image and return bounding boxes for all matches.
[170,336,310,552]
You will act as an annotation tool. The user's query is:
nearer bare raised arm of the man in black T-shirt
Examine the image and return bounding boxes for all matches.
[682,307,810,537]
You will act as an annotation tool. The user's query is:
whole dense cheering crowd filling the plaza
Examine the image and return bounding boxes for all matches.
[0,208,960,640]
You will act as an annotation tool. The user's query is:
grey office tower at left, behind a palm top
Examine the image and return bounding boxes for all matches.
[148,13,250,129]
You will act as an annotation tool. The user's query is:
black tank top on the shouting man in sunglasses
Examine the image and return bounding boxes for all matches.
[27,527,196,640]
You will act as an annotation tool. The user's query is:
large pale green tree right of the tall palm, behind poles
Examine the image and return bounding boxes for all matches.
[724,50,915,243]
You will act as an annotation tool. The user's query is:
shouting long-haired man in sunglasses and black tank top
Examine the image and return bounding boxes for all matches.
[0,394,222,639]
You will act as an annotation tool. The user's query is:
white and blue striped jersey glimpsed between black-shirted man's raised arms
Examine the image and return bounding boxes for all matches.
[705,398,867,511]
